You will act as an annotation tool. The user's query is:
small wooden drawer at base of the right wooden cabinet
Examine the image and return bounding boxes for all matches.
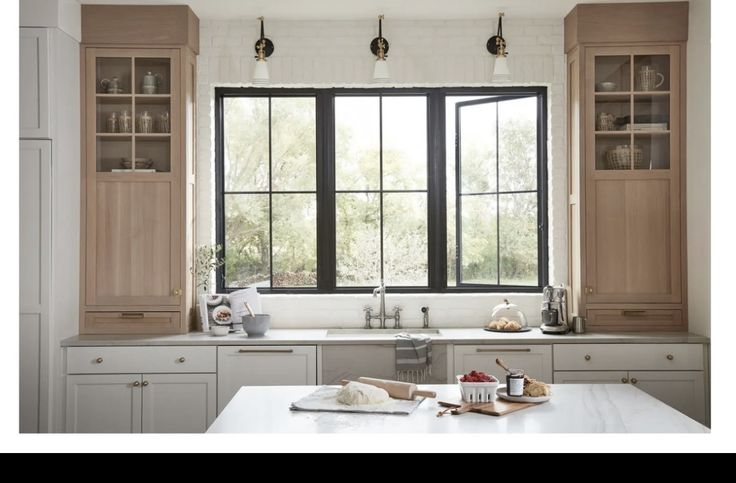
[586,309,686,331]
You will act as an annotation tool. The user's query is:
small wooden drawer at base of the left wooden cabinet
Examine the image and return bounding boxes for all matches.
[82,312,181,334]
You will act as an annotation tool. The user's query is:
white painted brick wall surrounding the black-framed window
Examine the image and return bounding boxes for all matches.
[197,18,567,327]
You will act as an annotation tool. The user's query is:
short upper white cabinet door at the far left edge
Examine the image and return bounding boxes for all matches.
[19,28,51,139]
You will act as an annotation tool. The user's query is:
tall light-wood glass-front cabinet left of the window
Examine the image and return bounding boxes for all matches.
[80,5,199,334]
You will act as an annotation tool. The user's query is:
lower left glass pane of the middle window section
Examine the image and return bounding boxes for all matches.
[335,193,381,287]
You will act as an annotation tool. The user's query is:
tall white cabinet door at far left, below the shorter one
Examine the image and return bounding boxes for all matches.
[19,141,51,433]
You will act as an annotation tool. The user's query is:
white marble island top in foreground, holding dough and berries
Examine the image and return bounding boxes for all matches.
[207,384,709,433]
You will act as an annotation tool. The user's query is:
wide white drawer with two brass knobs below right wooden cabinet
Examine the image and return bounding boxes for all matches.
[554,344,703,371]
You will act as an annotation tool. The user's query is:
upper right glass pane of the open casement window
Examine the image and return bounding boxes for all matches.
[498,97,537,191]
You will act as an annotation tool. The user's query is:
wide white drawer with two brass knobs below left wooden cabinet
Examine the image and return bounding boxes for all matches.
[66,346,217,374]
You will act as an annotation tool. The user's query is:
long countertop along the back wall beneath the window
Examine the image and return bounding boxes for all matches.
[61,327,710,347]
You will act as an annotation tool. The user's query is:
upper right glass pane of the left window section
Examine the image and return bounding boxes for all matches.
[271,97,317,191]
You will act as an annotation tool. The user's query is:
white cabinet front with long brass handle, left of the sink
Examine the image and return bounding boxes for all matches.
[217,346,317,413]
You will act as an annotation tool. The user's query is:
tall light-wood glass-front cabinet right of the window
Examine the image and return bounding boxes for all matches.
[565,2,688,331]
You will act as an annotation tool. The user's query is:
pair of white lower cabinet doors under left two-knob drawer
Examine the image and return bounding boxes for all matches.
[66,374,217,433]
